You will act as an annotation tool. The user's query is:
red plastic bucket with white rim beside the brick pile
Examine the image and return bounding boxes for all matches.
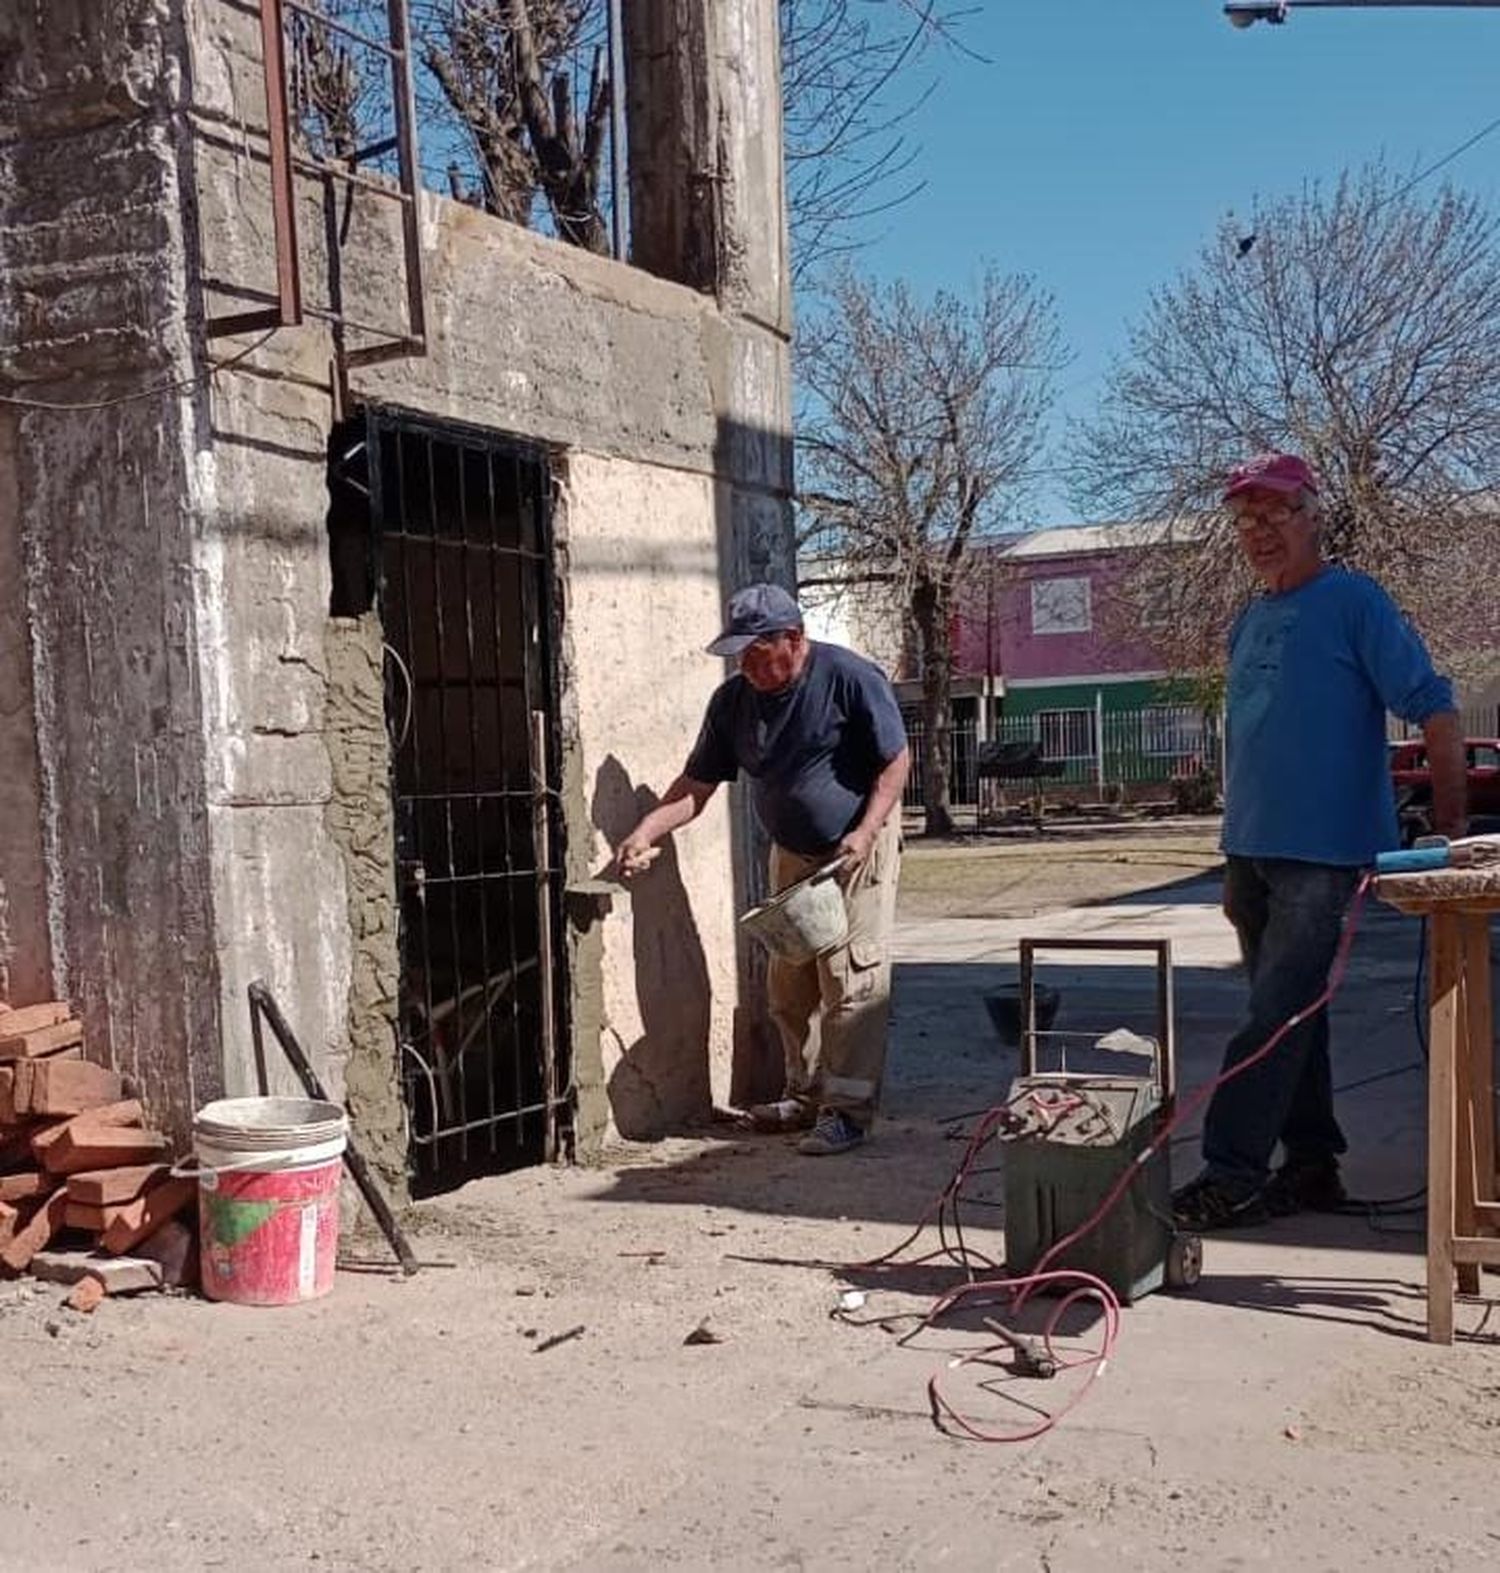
[193,1098,349,1306]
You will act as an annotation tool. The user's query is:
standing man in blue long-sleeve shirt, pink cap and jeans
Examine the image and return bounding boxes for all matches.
[1173,453,1465,1230]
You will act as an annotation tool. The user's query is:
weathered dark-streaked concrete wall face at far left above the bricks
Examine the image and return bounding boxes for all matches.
[0,0,220,1129]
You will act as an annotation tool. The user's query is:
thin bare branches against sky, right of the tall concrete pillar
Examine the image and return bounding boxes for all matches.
[778,0,976,283]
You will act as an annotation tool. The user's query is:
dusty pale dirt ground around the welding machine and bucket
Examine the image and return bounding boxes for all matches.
[0,826,1500,1573]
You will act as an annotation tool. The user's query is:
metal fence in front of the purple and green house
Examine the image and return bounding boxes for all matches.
[904,705,1223,809]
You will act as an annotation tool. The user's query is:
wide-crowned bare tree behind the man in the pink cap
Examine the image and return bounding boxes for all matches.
[1075,167,1500,682]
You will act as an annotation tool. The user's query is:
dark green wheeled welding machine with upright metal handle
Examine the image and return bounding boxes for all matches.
[1000,939,1203,1306]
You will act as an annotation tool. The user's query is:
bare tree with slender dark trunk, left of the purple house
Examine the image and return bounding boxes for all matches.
[799,269,1058,835]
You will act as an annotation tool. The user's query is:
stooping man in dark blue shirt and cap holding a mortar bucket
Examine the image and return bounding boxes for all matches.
[618,585,910,1155]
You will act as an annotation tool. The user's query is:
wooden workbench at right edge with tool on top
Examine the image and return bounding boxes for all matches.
[1376,867,1500,1343]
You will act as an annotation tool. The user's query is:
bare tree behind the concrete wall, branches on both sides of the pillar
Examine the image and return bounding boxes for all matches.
[279,0,969,273]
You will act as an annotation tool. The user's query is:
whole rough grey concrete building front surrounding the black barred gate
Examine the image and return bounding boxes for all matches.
[0,0,792,1181]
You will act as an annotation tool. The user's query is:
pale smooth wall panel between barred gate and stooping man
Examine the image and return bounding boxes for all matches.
[566,453,737,1137]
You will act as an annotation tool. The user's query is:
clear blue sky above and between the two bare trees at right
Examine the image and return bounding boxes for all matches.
[862,0,1500,524]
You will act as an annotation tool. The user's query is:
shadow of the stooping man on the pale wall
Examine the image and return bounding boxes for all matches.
[593,753,712,1140]
